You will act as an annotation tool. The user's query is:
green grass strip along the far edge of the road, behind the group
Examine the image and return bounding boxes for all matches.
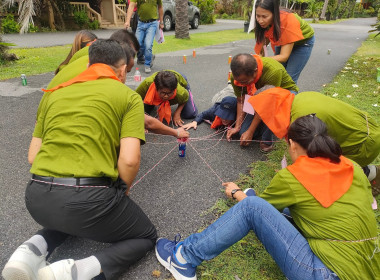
[0,27,254,80]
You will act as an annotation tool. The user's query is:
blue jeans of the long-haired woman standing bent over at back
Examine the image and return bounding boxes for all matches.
[275,36,315,84]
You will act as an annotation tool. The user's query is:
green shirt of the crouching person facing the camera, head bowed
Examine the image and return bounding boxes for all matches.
[136,70,189,105]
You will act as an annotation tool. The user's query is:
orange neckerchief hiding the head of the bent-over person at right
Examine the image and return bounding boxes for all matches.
[248,87,295,139]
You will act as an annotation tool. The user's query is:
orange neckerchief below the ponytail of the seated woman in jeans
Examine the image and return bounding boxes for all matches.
[287,156,354,208]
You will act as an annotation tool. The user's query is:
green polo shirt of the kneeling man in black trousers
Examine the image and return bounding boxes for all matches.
[30,79,145,180]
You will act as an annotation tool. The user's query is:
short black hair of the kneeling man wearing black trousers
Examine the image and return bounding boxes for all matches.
[88,39,127,68]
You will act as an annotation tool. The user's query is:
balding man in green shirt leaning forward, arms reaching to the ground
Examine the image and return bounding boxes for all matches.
[227,53,298,152]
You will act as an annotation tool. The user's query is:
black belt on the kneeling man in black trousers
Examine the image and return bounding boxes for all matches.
[32,174,112,187]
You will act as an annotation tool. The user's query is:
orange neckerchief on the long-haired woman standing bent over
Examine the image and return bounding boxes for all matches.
[255,11,305,54]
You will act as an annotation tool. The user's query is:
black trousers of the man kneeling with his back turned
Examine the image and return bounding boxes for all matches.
[25,180,157,279]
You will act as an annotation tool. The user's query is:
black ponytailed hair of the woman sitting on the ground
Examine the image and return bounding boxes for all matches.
[288,114,342,163]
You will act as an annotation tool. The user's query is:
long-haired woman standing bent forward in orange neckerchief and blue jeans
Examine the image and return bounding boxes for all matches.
[255,0,315,84]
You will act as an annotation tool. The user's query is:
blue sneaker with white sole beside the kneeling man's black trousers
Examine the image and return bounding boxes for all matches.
[156,235,197,280]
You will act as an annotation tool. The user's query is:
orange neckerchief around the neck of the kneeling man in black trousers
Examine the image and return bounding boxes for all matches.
[42,63,120,92]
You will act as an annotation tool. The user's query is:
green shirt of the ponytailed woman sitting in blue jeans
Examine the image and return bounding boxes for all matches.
[260,164,380,280]
